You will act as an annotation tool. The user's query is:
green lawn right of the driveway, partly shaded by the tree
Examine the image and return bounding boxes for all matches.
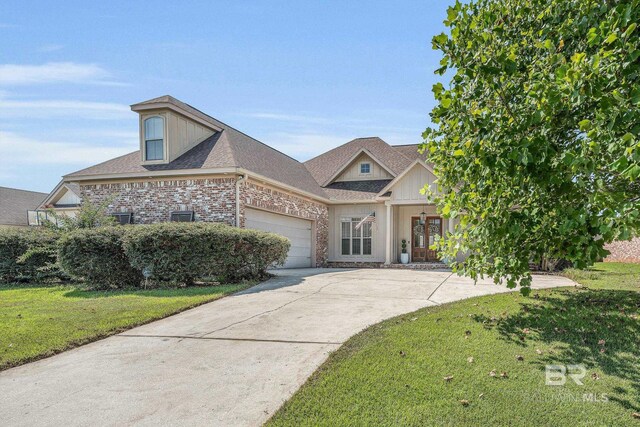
[269,264,640,427]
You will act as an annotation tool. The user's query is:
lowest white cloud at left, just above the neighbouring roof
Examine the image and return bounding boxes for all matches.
[0,131,135,167]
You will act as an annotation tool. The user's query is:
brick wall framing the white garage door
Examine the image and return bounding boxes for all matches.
[240,181,329,267]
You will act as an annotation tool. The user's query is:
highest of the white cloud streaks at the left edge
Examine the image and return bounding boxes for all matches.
[0,62,122,85]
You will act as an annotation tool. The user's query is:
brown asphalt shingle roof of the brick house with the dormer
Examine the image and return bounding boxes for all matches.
[65,95,430,200]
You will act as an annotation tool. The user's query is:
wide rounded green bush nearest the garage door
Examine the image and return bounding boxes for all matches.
[124,222,290,285]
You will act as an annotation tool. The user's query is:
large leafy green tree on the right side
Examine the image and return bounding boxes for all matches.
[423,0,640,292]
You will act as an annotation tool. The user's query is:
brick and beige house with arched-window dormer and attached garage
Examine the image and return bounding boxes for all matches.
[39,96,453,267]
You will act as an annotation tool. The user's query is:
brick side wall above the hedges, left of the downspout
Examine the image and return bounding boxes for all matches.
[80,177,236,225]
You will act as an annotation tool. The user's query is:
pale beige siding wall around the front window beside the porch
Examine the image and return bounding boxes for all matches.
[329,203,387,262]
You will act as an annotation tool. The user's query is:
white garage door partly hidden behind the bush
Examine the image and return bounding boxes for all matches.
[245,209,311,268]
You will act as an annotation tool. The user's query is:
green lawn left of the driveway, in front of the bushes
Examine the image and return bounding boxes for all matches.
[0,284,249,370]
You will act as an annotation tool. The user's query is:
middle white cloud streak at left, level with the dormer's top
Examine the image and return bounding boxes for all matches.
[0,94,132,119]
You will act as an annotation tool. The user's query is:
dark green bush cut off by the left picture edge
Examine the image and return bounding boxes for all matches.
[0,228,64,282]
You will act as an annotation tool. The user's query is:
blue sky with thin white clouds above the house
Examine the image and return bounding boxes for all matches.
[0,0,453,192]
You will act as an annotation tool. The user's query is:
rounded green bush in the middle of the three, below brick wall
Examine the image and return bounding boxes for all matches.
[58,226,143,288]
